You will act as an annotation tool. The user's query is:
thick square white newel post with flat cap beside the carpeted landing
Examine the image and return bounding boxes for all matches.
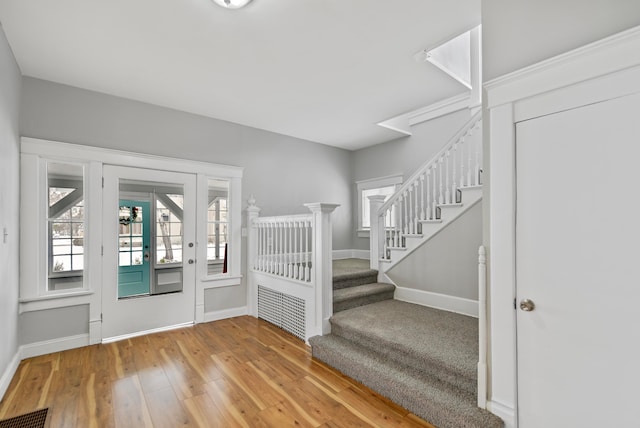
[304,202,340,335]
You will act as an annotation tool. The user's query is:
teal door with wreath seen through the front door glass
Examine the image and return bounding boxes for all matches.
[118,199,151,299]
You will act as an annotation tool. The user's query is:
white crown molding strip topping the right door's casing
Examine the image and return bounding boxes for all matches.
[484,26,640,108]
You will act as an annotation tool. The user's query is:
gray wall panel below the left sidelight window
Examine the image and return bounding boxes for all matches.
[19,305,89,345]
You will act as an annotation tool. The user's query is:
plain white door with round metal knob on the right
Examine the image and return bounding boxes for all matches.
[516,94,640,428]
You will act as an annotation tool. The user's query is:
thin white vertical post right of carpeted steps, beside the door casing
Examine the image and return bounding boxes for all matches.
[478,245,487,409]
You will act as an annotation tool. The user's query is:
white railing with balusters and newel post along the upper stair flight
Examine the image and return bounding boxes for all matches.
[370,112,482,274]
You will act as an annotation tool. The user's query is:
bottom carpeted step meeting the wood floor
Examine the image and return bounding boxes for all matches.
[309,334,503,428]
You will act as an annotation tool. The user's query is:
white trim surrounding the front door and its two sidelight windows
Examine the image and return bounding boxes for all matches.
[19,137,243,326]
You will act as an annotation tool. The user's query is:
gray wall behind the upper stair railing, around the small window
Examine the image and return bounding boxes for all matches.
[351,110,471,250]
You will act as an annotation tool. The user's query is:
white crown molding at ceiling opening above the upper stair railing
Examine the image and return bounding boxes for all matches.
[377,92,471,135]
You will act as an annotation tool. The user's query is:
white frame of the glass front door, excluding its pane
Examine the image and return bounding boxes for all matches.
[102,165,197,342]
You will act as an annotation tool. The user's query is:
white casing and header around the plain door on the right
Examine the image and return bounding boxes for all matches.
[485,27,640,428]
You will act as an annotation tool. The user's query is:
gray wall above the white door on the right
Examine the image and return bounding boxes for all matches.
[482,0,640,82]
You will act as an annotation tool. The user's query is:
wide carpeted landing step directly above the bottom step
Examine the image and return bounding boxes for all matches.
[330,300,478,394]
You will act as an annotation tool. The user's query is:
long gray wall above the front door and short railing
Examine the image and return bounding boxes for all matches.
[20,77,352,328]
